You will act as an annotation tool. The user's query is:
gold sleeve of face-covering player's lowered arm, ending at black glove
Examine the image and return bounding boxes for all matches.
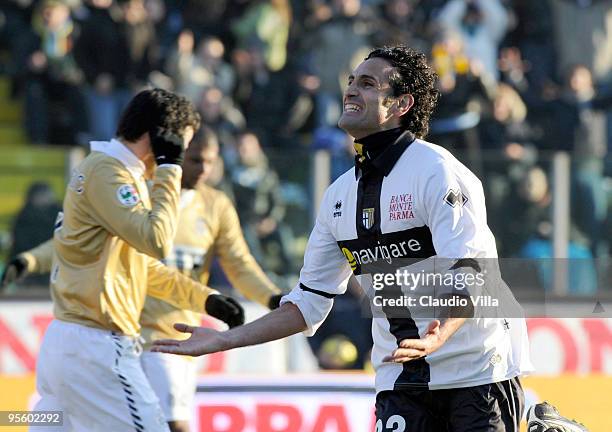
[147,257,218,312]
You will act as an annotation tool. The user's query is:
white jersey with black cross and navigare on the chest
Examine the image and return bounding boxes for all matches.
[282,132,531,391]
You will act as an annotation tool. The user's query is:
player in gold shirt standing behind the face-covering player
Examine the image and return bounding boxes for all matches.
[3,127,281,432]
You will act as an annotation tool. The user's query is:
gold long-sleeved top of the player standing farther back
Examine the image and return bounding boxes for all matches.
[22,165,280,347]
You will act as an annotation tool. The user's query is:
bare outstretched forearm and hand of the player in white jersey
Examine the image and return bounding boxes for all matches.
[151,303,307,356]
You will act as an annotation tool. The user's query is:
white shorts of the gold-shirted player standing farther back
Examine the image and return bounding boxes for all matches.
[140,351,197,421]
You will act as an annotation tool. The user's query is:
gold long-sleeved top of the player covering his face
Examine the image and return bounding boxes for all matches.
[35,140,214,336]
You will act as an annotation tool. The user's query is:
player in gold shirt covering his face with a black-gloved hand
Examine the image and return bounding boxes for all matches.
[5,89,242,432]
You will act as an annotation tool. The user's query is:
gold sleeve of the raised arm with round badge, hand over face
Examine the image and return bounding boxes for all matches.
[85,164,181,259]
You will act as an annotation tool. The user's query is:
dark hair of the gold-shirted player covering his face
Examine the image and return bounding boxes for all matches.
[117,88,200,141]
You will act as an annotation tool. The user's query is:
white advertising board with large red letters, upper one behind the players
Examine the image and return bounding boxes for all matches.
[0,302,612,375]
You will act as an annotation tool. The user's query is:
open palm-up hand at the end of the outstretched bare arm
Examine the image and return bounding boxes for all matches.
[151,324,230,357]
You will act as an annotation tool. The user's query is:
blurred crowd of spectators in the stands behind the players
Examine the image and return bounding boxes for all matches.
[0,0,612,368]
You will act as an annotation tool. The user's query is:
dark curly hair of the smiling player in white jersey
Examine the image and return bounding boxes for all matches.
[365,45,440,138]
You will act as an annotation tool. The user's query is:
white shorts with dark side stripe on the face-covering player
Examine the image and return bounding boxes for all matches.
[34,320,169,432]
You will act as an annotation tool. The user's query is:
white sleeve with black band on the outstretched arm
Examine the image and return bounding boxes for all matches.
[281,193,352,336]
